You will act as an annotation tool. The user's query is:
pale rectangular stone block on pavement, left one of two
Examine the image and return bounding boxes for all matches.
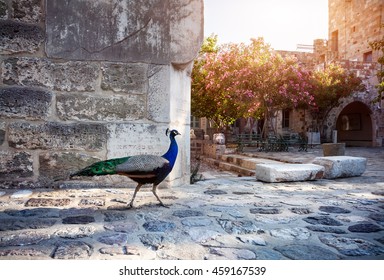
[255,163,324,183]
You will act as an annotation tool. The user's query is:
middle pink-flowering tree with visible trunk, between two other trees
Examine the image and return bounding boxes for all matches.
[234,42,313,135]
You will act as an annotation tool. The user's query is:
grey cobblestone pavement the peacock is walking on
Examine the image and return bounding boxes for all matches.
[0,148,384,260]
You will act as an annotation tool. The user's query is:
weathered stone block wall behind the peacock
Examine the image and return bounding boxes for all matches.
[0,0,203,188]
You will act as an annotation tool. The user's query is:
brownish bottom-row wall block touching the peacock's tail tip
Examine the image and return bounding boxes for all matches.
[39,152,101,179]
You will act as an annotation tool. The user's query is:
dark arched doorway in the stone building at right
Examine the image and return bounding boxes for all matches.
[336,101,373,147]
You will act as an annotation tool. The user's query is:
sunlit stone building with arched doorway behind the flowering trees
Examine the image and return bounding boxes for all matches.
[276,0,384,147]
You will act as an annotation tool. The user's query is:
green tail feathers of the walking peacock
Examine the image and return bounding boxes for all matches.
[71,157,129,177]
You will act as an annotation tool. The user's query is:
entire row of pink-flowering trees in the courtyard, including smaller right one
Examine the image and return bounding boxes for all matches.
[192,36,363,139]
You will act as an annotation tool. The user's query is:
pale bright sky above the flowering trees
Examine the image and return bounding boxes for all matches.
[204,0,328,51]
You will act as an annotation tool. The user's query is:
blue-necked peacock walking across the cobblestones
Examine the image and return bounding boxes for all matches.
[70,129,181,208]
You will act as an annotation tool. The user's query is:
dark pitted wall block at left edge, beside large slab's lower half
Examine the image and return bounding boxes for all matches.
[0,20,44,54]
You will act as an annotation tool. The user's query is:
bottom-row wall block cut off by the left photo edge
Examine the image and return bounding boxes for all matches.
[0,151,33,180]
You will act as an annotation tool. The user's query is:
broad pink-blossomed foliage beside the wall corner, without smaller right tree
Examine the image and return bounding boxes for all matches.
[192,37,313,133]
